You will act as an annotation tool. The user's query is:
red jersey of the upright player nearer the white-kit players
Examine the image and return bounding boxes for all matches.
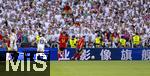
[59,34,68,48]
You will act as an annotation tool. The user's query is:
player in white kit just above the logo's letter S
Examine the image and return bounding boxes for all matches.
[36,34,47,60]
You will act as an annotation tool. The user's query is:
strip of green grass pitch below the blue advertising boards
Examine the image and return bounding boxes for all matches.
[50,61,150,76]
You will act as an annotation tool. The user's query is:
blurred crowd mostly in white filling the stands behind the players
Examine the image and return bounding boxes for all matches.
[0,0,150,48]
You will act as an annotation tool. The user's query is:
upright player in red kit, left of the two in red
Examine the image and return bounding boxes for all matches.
[58,32,68,60]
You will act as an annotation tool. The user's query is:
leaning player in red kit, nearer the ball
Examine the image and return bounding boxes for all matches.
[72,36,85,60]
